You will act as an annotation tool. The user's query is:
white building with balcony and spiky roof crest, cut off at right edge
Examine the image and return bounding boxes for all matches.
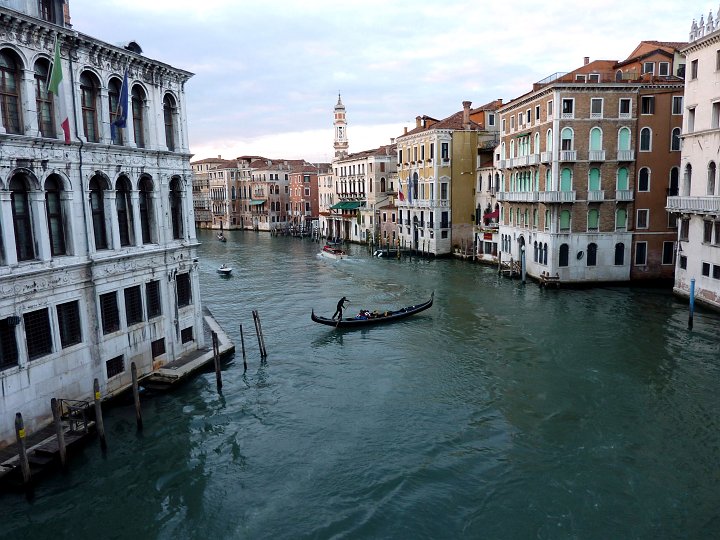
[667,10,720,309]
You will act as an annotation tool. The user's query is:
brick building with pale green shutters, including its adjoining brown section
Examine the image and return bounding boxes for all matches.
[498,42,684,283]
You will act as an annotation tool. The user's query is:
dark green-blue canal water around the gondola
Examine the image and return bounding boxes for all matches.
[0,231,720,540]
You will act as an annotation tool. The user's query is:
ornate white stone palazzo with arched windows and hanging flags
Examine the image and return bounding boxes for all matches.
[0,0,211,446]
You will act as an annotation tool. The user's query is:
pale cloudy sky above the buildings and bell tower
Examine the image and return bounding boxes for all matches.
[70,0,704,161]
